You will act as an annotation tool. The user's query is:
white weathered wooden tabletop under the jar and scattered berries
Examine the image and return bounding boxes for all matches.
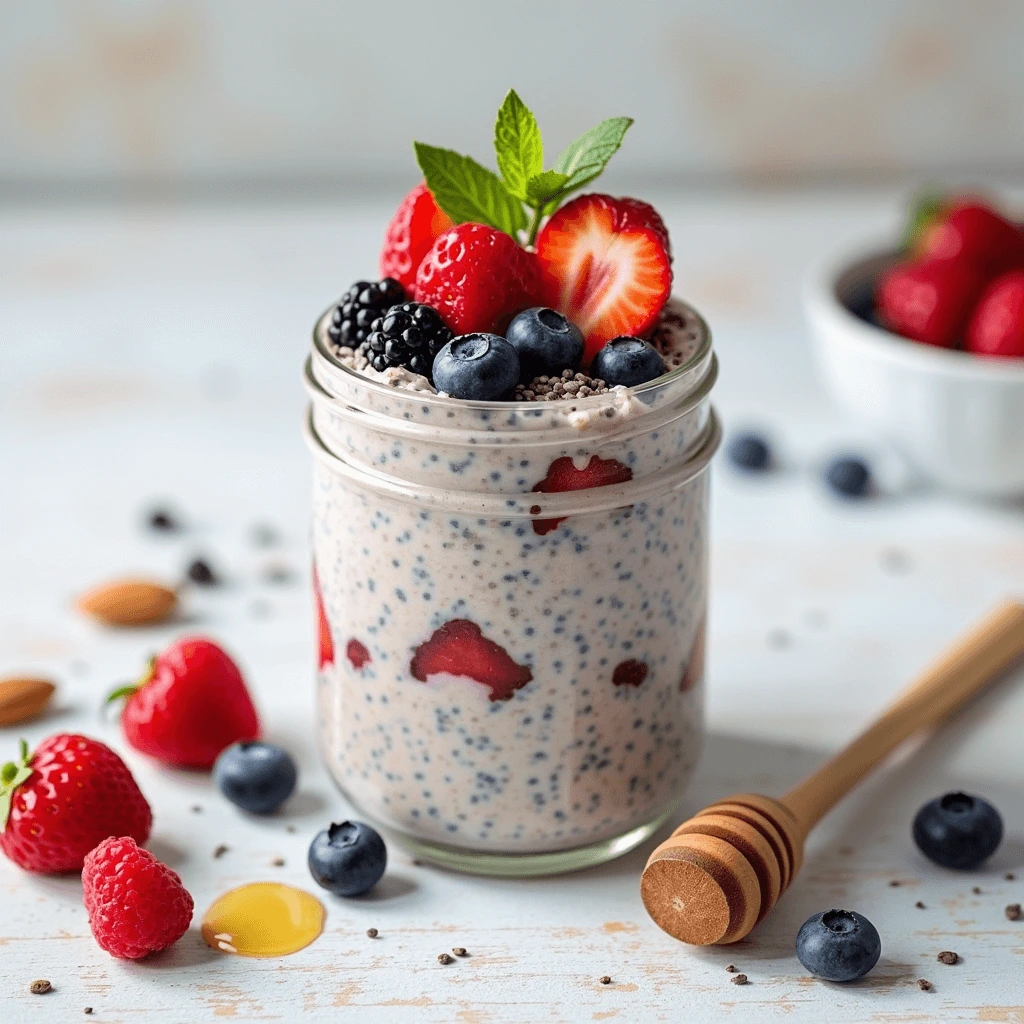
[0,195,1024,1024]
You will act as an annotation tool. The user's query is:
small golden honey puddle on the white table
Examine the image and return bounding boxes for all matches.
[202,882,327,956]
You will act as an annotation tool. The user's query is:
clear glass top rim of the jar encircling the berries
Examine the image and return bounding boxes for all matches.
[312,296,712,414]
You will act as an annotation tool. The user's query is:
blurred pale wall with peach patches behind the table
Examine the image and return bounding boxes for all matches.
[0,0,1024,198]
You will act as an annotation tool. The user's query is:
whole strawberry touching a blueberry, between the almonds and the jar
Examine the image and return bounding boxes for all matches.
[109,637,260,768]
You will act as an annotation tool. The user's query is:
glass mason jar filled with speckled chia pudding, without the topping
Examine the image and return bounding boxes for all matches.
[306,301,719,876]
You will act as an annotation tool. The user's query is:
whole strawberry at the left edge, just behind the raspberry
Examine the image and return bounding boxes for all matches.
[0,732,153,874]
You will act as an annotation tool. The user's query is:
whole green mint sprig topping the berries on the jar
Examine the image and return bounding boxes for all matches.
[414,89,633,245]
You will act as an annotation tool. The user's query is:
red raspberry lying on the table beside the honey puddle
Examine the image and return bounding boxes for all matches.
[82,836,193,959]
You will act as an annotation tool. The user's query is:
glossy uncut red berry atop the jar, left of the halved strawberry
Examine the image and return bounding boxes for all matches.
[416,224,540,334]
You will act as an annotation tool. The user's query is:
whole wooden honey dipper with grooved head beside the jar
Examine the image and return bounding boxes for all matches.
[640,601,1024,946]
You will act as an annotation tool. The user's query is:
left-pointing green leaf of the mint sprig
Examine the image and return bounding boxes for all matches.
[413,142,526,238]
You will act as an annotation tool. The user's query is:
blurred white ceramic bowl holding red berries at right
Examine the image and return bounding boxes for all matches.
[804,252,1024,498]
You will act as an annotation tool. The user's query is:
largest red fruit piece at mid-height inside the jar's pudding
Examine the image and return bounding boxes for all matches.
[409,618,534,701]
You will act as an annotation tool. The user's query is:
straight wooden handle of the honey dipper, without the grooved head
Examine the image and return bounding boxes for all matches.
[782,601,1024,835]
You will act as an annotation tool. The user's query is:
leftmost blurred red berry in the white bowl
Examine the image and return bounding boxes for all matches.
[874,260,982,348]
